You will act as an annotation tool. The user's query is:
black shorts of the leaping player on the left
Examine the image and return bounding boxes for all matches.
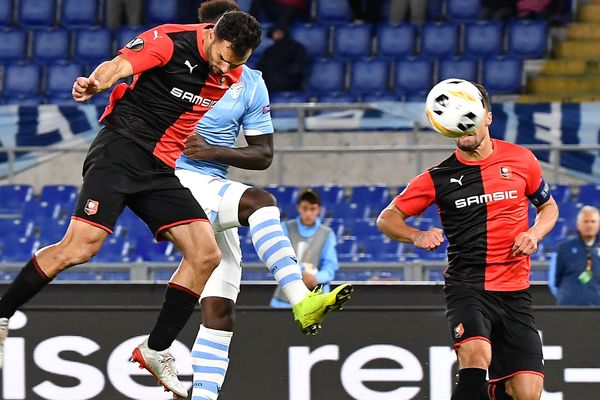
[73,128,207,238]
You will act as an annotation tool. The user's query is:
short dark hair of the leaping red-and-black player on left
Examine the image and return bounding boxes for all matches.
[215,11,262,57]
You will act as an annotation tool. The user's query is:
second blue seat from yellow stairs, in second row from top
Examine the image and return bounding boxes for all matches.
[464,21,504,57]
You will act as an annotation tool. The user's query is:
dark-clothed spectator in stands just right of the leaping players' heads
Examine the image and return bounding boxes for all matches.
[257,28,307,92]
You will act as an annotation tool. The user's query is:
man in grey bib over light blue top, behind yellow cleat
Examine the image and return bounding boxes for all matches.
[271,189,338,308]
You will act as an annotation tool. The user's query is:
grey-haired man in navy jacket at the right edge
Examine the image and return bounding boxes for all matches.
[549,206,600,306]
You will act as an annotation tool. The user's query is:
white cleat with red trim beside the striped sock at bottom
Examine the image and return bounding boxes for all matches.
[131,339,187,398]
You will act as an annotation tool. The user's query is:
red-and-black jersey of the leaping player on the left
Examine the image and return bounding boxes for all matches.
[100,24,243,167]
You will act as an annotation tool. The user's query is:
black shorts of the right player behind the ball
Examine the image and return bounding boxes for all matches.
[444,285,543,381]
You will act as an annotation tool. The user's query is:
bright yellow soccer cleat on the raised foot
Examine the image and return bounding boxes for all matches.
[292,283,353,335]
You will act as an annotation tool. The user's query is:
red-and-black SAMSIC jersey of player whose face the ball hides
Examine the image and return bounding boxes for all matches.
[394,139,545,291]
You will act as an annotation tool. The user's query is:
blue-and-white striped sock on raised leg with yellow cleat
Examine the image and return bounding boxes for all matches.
[248,206,309,306]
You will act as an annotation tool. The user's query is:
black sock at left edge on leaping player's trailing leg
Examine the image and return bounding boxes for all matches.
[0,256,52,318]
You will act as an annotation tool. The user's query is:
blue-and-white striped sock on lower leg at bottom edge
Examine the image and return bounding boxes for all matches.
[192,325,233,400]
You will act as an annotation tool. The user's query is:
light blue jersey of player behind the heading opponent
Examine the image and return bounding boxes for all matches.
[177,65,274,178]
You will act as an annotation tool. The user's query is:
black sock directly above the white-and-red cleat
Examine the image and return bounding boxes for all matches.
[148,283,200,351]
